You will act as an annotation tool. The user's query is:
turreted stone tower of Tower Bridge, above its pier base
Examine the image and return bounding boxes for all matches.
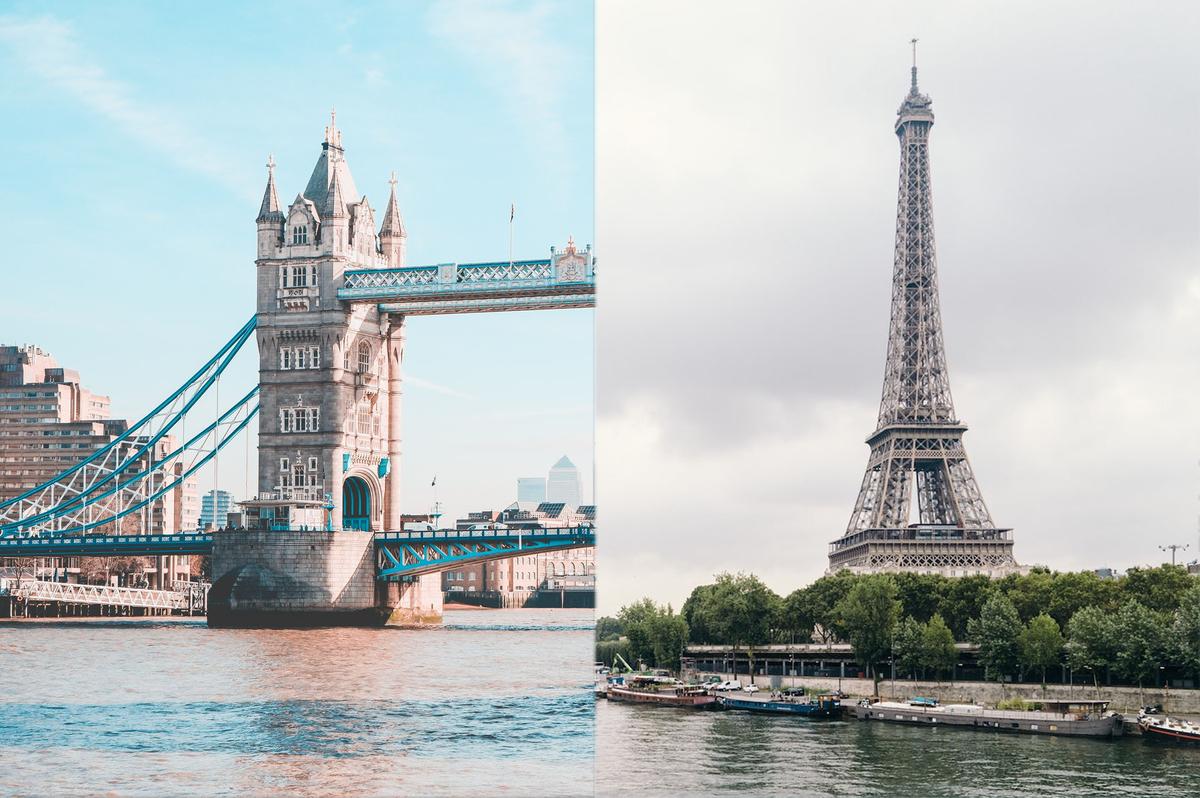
[250,118,407,530]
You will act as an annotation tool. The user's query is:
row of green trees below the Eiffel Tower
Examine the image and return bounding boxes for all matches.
[598,565,1200,684]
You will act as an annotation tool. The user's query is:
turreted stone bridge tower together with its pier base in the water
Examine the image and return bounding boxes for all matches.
[209,116,442,626]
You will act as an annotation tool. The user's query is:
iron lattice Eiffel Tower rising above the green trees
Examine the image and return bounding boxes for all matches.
[829,48,1019,576]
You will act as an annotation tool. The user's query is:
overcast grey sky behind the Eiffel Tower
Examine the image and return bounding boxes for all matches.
[596,0,1200,613]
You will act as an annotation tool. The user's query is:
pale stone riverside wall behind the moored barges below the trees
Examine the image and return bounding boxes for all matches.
[700,673,1200,716]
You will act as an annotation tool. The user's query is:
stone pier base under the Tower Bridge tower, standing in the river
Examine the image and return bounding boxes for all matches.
[208,530,442,628]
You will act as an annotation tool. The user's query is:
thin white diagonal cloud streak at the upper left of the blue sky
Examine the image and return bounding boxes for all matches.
[0,16,250,199]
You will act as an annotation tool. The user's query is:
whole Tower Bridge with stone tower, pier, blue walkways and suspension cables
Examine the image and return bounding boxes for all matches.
[0,116,595,625]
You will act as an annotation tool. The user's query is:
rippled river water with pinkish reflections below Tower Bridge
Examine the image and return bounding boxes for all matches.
[0,610,594,797]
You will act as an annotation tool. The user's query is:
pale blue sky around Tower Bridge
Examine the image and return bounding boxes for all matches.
[0,1,593,523]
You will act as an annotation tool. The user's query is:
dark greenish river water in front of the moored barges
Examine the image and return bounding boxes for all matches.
[596,701,1200,798]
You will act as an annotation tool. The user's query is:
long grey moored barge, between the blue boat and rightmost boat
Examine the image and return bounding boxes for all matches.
[854,700,1124,737]
